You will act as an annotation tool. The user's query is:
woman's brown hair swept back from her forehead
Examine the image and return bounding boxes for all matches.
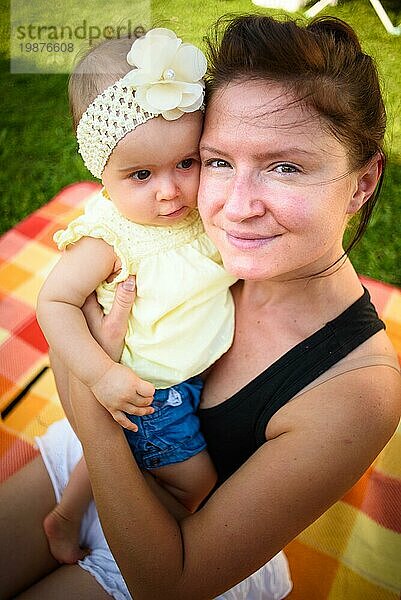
[207,15,386,252]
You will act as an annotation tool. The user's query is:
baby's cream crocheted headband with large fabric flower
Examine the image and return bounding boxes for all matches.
[77,28,207,179]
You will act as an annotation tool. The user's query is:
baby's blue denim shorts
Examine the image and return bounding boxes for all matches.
[124,377,206,469]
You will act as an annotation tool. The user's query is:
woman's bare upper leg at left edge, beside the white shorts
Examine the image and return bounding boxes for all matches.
[0,457,59,599]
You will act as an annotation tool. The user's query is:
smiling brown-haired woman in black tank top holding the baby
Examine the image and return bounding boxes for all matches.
[1,16,401,600]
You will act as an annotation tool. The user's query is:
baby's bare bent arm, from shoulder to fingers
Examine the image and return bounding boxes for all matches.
[38,238,154,430]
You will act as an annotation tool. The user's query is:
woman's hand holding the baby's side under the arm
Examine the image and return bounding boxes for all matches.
[82,275,136,362]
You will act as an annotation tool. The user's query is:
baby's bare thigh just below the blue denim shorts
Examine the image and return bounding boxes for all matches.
[149,450,217,512]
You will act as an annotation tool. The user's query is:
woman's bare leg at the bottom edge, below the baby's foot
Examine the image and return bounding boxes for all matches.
[15,565,111,600]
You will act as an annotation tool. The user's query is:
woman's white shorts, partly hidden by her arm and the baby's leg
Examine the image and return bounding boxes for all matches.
[36,419,292,600]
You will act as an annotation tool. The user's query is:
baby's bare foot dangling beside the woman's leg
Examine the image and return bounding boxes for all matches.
[43,506,88,565]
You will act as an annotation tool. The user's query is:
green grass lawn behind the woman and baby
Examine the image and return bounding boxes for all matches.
[0,0,401,285]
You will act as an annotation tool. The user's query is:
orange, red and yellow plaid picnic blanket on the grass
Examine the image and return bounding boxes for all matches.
[0,182,401,600]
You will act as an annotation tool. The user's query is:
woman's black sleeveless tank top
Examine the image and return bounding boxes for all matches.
[198,289,385,484]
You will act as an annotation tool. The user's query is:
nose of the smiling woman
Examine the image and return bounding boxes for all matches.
[223,177,266,222]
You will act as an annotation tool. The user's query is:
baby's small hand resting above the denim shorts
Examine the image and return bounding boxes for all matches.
[91,363,155,431]
